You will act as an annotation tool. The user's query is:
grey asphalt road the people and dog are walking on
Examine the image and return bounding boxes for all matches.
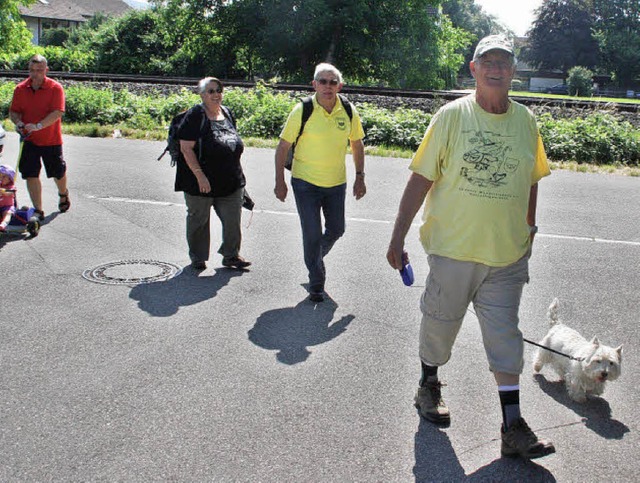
[0,133,640,482]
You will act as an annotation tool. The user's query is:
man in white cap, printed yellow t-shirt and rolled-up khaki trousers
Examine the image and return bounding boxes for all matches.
[387,35,555,459]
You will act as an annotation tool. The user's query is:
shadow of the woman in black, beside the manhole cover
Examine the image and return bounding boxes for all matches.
[129,267,244,317]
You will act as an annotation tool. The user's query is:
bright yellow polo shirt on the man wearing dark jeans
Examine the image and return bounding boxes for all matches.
[280,94,364,188]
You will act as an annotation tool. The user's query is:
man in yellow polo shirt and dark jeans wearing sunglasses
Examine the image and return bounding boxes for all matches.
[274,63,367,302]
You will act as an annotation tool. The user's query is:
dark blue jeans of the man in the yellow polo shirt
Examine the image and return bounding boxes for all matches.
[291,178,347,292]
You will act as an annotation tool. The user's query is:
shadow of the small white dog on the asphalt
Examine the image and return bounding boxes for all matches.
[533,374,629,439]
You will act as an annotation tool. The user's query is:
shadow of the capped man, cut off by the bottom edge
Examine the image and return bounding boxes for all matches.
[413,418,556,482]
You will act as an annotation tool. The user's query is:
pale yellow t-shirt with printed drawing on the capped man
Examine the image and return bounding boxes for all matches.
[410,94,550,267]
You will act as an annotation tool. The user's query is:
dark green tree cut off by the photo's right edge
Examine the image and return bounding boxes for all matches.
[593,0,640,87]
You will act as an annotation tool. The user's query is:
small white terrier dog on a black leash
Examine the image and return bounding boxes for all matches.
[533,299,622,402]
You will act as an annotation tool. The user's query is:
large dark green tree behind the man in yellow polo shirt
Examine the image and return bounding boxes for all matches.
[221,0,466,87]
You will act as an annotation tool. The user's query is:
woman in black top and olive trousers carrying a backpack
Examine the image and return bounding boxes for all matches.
[175,77,251,270]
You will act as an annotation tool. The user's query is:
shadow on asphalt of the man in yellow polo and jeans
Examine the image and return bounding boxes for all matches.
[248,297,355,365]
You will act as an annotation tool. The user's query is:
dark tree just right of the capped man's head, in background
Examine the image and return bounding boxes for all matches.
[522,0,600,73]
